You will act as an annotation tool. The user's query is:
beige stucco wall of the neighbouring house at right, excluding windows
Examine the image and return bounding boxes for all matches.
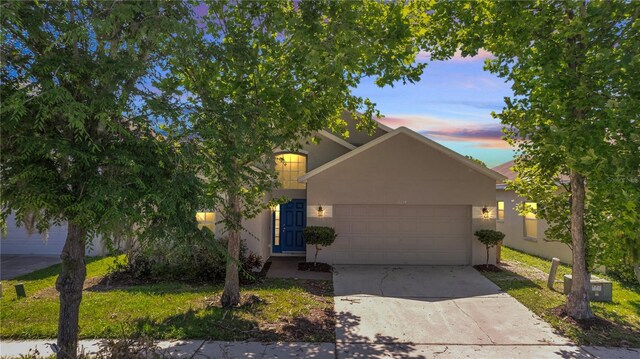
[496,190,572,263]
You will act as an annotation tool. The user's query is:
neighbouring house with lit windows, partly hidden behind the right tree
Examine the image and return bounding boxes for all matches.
[493,161,572,263]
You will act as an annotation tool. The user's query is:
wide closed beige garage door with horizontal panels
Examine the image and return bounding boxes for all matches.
[330,205,471,265]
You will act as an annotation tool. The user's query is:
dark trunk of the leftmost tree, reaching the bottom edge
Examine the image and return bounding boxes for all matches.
[56,222,87,359]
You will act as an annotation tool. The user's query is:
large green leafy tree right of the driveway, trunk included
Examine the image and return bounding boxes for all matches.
[426,1,640,319]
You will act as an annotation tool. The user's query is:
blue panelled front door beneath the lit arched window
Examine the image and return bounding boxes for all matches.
[280,199,307,252]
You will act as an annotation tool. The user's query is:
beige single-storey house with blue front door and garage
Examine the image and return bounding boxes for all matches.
[208,116,504,265]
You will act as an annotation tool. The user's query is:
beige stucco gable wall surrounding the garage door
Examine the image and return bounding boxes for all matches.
[307,133,496,264]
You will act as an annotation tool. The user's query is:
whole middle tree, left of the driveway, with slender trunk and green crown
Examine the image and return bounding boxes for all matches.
[156,1,424,307]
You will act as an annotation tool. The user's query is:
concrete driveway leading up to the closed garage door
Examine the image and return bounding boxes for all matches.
[333,266,590,358]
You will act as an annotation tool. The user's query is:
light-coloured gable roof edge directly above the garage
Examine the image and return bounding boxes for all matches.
[298,127,505,182]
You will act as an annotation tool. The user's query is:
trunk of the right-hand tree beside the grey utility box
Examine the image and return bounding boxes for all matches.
[567,170,593,319]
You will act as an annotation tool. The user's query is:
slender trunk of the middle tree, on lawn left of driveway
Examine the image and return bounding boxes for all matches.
[220,191,242,308]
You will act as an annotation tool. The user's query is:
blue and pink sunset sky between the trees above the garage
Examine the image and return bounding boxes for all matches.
[354,51,514,167]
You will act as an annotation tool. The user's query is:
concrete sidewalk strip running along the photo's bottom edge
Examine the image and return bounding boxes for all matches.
[0,339,640,359]
